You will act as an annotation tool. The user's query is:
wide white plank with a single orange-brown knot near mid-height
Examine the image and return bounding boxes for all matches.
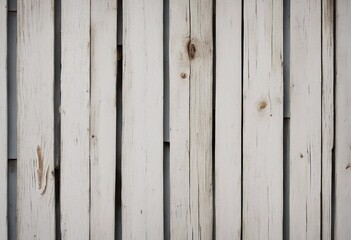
[243,0,283,239]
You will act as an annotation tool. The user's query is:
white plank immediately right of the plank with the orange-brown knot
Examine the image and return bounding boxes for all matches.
[290,0,322,239]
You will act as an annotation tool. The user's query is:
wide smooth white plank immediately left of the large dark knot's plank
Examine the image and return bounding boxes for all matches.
[122,0,163,239]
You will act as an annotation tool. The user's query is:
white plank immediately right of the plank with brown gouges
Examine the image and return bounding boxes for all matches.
[60,0,90,239]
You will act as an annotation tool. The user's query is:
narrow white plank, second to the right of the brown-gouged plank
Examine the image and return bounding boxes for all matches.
[90,0,117,239]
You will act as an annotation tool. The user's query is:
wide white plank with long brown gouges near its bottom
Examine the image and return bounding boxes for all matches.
[17,0,55,239]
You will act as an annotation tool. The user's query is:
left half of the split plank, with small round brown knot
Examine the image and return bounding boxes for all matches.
[168,0,192,239]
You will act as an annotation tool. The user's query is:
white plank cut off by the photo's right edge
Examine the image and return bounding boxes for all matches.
[334,0,351,239]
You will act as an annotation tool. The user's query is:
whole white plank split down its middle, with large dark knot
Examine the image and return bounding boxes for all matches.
[169,0,213,239]
